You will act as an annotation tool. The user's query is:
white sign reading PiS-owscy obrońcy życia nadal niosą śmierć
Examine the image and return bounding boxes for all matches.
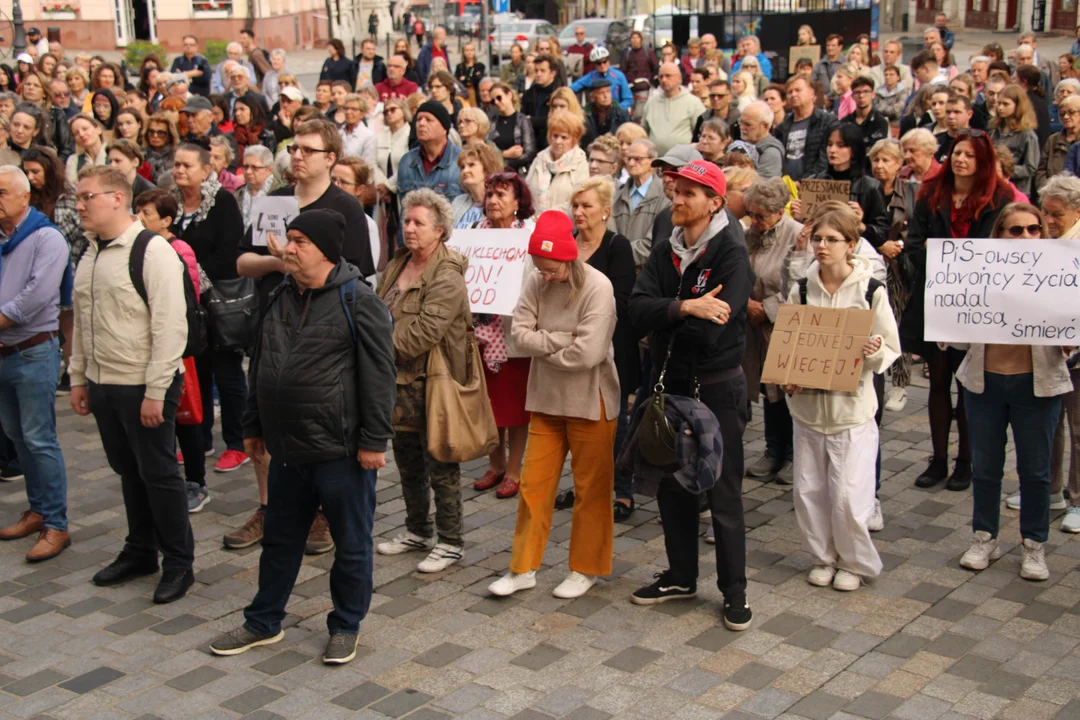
[924,239,1080,345]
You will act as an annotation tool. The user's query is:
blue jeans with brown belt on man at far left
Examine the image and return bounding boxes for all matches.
[0,338,67,530]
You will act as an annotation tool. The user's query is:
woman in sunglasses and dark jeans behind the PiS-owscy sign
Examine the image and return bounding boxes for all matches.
[956,203,1072,580]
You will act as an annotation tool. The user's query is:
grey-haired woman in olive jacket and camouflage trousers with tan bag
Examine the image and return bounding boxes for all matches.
[376,188,472,572]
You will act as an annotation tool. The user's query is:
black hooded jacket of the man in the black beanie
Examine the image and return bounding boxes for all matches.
[244,259,396,464]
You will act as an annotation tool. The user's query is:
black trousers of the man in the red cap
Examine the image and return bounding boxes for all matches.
[657,373,748,598]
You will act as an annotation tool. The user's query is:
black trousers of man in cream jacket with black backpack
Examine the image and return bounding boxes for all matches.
[90,375,195,571]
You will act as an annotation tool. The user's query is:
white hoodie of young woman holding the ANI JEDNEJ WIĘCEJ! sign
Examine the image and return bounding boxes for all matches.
[787,255,900,435]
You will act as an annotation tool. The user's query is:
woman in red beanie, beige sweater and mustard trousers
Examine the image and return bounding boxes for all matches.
[487,210,619,598]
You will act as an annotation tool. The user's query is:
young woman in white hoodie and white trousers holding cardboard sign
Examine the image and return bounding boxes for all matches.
[784,202,900,592]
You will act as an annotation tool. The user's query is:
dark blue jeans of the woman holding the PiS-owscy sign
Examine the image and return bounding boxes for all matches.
[963,372,1062,543]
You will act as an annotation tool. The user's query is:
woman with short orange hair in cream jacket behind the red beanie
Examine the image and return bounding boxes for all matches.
[525,110,589,215]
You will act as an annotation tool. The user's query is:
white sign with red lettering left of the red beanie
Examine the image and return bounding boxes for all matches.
[446,229,531,315]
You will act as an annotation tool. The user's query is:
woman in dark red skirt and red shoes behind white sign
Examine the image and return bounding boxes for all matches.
[473,171,532,498]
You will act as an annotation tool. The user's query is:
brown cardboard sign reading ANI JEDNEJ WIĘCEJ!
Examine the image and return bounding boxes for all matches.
[761,304,874,393]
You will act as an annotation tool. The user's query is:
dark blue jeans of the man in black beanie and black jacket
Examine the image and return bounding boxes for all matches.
[244,458,376,635]
